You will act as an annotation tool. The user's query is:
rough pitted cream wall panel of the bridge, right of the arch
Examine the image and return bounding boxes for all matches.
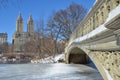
[89,51,120,80]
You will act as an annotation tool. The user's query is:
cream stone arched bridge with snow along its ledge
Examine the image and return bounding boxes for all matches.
[65,0,120,80]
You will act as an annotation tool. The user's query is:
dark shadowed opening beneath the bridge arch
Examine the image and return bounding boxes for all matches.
[68,47,97,69]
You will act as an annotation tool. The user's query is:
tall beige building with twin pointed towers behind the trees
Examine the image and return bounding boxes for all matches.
[12,13,35,52]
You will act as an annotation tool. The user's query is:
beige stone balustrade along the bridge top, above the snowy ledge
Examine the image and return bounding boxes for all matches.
[69,0,120,43]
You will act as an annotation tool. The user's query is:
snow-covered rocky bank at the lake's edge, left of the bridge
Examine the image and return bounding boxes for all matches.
[31,53,65,63]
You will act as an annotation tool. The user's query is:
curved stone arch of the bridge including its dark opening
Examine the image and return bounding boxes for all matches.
[66,44,109,80]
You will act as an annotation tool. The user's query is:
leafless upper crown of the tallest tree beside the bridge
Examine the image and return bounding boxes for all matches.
[48,3,86,40]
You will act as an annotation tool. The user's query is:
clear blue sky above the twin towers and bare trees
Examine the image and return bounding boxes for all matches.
[0,0,95,43]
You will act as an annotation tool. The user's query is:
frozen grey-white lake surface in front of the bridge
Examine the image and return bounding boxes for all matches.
[0,64,103,80]
